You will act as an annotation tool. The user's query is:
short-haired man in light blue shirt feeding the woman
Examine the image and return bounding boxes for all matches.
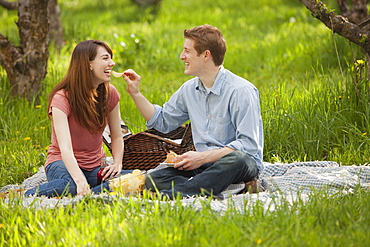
[123,25,263,198]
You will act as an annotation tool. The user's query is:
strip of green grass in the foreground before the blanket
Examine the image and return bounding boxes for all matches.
[0,188,370,247]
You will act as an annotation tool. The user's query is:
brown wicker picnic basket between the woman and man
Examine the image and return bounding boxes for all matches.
[103,124,195,170]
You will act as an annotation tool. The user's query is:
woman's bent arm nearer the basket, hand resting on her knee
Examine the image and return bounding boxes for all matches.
[102,103,123,180]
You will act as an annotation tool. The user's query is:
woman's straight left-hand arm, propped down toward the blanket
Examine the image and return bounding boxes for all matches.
[52,107,91,195]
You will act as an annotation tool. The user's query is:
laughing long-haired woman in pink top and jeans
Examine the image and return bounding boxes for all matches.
[25,40,130,197]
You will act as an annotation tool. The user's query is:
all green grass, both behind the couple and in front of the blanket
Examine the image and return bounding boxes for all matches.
[0,0,370,246]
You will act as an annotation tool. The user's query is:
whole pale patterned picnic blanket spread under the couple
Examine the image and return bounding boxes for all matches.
[0,161,370,213]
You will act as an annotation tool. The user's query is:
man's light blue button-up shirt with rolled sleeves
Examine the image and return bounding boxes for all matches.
[147,66,263,172]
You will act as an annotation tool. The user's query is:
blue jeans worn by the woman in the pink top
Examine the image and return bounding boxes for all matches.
[25,160,132,197]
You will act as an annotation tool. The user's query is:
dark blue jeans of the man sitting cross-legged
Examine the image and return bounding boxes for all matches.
[145,151,259,199]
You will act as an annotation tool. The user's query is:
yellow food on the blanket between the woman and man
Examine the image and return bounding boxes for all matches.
[109,169,145,194]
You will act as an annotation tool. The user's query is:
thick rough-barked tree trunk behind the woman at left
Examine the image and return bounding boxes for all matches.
[0,0,49,101]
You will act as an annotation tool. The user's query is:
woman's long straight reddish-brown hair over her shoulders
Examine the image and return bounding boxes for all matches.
[48,40,113,133]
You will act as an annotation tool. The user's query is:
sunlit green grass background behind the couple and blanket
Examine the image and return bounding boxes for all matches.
[0,0,370,185]
